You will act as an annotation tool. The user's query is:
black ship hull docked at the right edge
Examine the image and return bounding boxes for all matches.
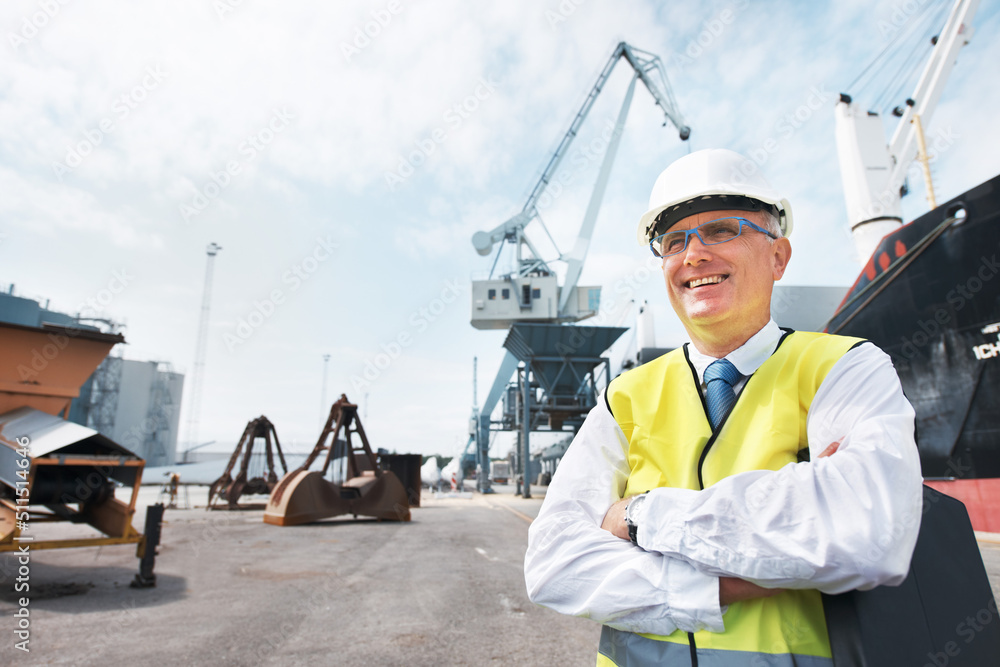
[827,176,1000,488]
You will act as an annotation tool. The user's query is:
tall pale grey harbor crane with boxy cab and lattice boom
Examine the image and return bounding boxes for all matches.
[463,42,691,493]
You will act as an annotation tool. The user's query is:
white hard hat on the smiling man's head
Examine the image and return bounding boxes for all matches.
[637,148,792,245]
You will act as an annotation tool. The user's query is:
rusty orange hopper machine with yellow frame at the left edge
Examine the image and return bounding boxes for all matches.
[0,323,163,587]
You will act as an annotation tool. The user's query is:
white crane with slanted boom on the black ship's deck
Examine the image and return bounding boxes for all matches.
[835,0,979,262]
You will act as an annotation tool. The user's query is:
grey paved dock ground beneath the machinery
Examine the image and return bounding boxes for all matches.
[0,486,1000,667]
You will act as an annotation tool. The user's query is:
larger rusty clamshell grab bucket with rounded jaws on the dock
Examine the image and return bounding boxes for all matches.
[264,394,410,526]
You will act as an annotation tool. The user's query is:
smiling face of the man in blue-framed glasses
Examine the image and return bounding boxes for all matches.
[663,210,792,357]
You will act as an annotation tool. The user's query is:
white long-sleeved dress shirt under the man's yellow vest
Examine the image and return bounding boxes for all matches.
[524,321,922,635]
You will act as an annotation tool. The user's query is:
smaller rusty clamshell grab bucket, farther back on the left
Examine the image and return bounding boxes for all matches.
[206,415,288,510]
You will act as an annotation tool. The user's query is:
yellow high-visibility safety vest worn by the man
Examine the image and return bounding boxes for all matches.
[607,332,861,667]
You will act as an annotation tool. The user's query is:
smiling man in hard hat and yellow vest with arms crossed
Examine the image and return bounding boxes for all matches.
[525,150,921,667]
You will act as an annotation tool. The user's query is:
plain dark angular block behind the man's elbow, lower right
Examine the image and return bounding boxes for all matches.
[823,486,1000,667]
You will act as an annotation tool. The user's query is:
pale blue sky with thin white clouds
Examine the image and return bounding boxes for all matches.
[0,0,1000,456]
